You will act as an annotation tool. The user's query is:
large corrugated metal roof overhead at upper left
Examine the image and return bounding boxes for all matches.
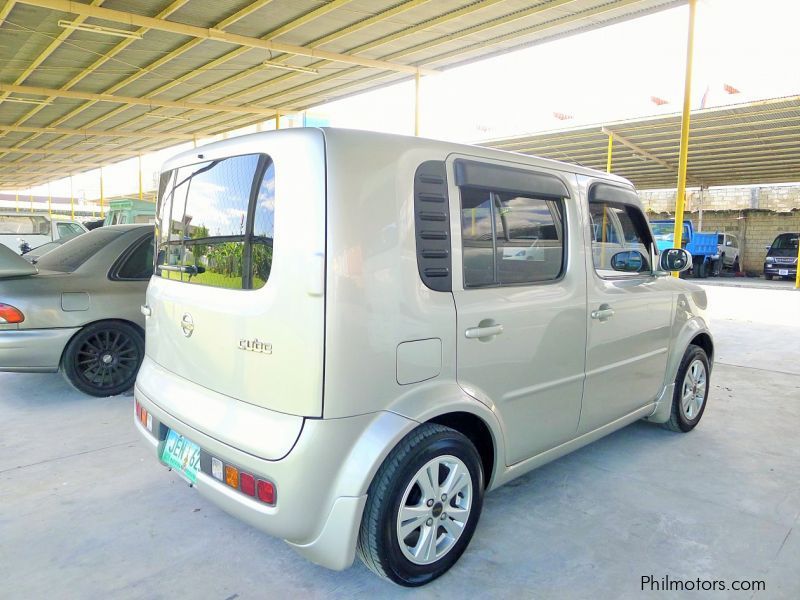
[0,0,686,187]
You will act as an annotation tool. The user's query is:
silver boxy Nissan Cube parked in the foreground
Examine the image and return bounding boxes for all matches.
[135,129,714,586]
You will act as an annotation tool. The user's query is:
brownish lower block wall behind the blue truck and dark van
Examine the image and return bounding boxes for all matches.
[645,204,800,274]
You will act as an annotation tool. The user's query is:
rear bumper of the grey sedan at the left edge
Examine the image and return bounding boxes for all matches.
[0,327,79,373]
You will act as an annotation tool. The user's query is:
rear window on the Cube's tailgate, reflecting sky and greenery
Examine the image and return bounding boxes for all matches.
[156,154,275,289]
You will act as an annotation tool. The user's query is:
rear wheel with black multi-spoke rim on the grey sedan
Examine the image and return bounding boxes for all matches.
[61,321,144,398]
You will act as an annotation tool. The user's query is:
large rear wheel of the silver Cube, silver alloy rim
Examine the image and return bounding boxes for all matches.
[357,423,484,587]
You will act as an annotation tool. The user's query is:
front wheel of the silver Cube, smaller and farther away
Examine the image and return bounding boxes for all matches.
[664,344,711,433]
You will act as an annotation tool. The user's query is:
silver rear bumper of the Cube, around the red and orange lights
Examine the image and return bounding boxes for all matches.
[134,384,415,570]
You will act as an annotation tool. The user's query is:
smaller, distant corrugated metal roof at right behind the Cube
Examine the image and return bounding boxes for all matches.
[481,96,800,189]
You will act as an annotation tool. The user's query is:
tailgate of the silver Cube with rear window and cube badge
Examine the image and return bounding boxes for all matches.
[146,132,325,416]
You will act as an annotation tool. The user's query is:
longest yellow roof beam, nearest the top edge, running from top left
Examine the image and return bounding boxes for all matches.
[18,0,436,75]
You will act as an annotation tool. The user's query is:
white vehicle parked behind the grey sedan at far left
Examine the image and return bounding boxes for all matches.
[0,211,87,254]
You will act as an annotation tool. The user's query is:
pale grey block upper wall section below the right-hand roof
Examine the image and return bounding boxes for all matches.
[639,185,800,212]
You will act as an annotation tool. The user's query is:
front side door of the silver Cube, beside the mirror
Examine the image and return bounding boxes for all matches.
[579,176,673,433]
